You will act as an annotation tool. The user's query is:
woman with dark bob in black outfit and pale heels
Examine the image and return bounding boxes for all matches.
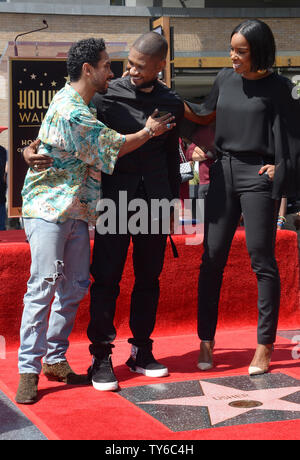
[188,20,300,375]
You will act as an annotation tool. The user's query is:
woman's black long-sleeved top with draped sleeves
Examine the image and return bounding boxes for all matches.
[185,69,300,198]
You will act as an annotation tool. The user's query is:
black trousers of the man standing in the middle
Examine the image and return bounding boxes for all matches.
[88,182,167,354]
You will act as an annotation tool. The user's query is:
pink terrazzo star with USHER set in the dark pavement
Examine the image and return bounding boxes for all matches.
[139,380,300,425]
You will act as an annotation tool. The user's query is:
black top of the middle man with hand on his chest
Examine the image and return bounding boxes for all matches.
[93,77,184,197]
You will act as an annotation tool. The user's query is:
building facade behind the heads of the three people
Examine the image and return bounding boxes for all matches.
[0,0,300,145]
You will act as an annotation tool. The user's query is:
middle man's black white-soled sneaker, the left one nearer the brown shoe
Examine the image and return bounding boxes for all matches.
[88,355,119,391]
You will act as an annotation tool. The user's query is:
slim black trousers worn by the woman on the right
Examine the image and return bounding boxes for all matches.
[198,154,280,344]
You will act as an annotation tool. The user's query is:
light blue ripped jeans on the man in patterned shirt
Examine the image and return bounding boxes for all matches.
[19,218,90,374]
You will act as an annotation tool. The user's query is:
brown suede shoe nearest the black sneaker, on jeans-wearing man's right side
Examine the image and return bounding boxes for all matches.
[43,361,89,385]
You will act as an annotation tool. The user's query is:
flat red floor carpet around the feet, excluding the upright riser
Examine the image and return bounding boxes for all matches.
[0,329,300,441]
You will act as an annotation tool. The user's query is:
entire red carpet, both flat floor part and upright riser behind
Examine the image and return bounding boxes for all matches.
[0,231,300,441]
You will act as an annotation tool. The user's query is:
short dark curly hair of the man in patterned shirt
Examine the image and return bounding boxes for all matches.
[67,38,106,81]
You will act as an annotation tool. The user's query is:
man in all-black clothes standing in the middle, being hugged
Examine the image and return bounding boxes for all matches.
[88,32,184,391]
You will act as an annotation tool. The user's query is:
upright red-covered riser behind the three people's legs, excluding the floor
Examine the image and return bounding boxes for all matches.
[0,230,300,347]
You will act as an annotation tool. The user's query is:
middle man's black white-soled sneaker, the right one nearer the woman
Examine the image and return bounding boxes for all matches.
[126,345,169,377]
